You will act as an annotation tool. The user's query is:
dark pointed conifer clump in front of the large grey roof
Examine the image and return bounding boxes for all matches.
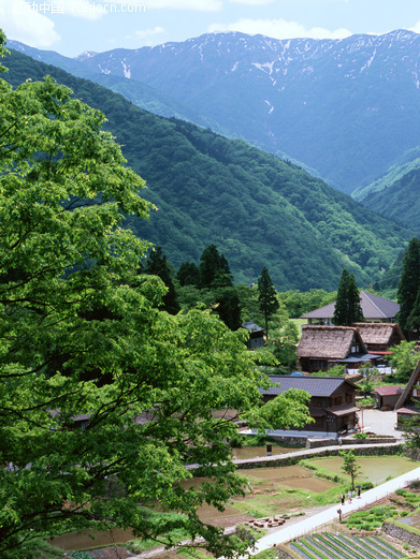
[333,269,364,326]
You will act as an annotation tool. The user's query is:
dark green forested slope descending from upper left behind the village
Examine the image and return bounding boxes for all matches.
[5,48,413,291]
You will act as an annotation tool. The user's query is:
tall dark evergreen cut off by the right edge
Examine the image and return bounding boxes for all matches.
[397,237,420,335]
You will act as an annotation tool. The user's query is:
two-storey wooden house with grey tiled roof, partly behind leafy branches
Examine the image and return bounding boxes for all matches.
[260,375,359,438]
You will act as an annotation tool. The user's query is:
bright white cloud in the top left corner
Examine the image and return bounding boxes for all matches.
[0,0,60,48]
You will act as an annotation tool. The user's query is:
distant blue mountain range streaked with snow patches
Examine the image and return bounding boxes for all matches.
[9,31,420,197]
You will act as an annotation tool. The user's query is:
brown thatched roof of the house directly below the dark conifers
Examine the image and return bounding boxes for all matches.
[297,325,367,359]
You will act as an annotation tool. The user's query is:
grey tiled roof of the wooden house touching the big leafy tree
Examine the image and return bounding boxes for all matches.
[260,376,354,396]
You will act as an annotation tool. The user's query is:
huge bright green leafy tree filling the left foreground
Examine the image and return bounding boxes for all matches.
[0,36,316,559]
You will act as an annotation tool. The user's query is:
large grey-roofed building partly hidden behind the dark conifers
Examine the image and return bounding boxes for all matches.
[301,291,400,324]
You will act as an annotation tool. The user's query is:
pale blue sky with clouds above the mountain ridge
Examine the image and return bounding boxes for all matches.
[0,0,420,56]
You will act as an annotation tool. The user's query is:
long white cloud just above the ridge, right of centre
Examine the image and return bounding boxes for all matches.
[208,19,352,39]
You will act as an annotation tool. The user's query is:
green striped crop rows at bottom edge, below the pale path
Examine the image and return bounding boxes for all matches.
[290,533,406,559]
